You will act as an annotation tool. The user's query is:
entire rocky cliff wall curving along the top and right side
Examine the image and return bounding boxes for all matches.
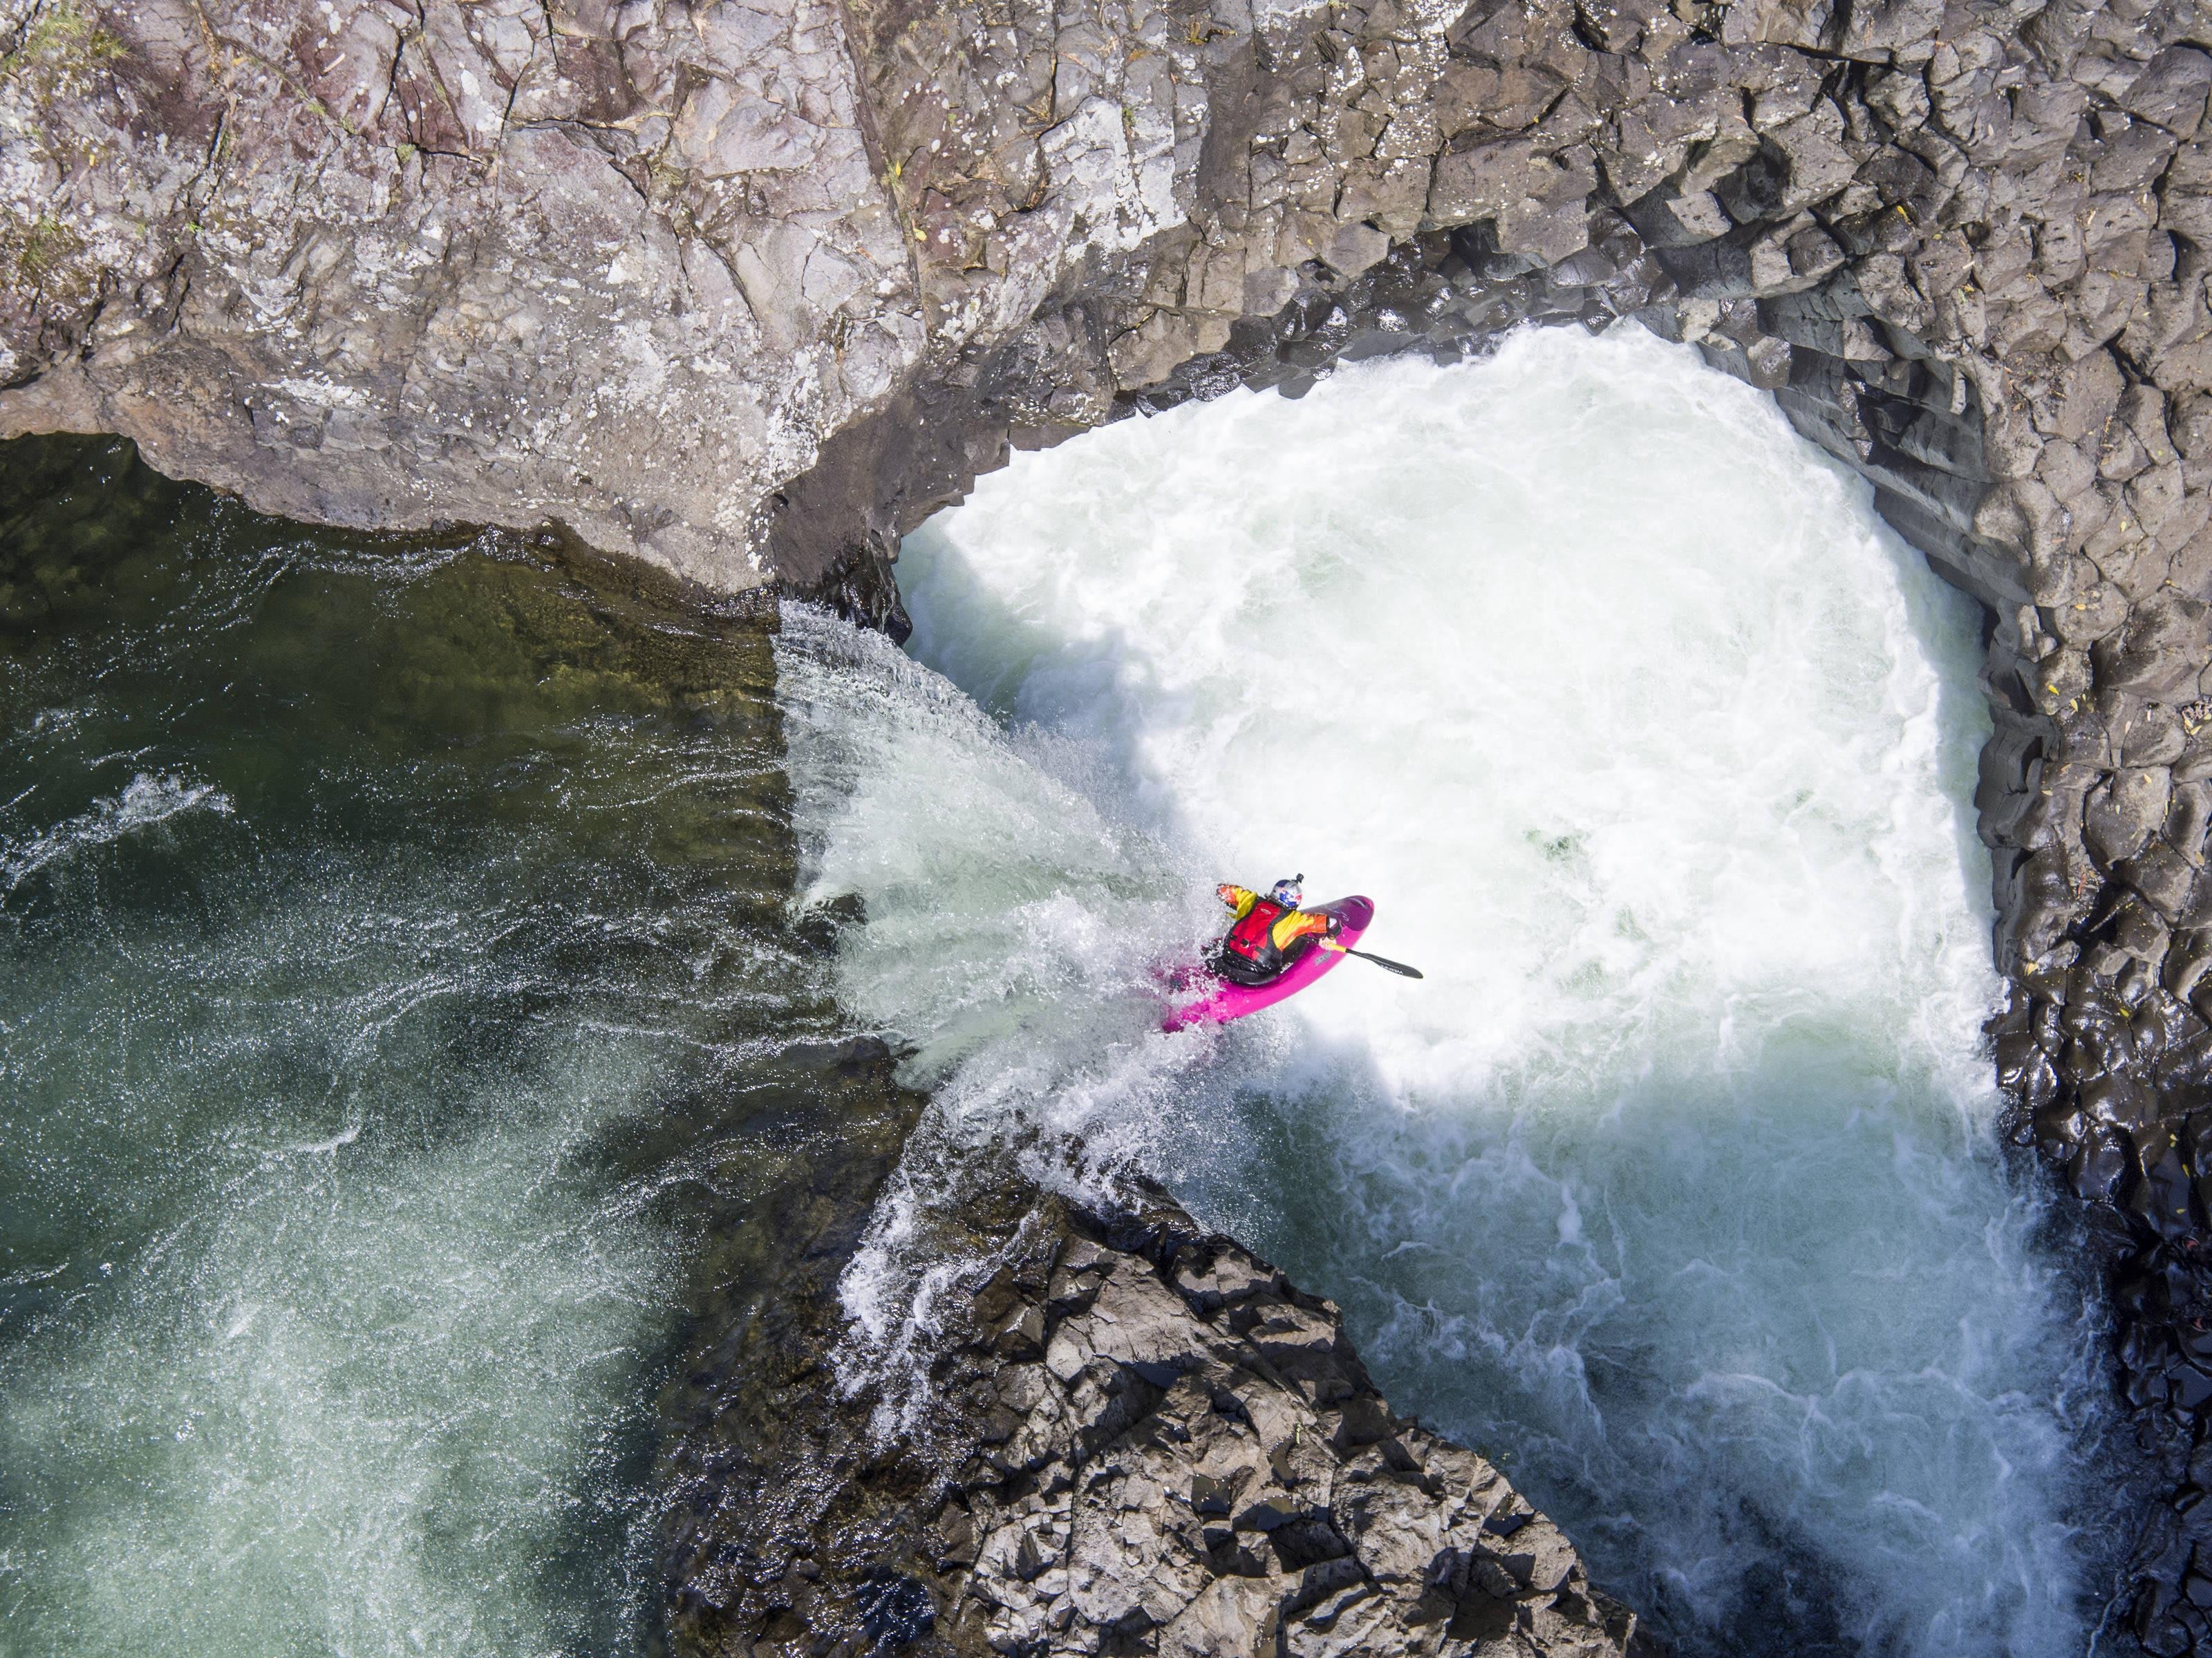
[21,0,2212,1654]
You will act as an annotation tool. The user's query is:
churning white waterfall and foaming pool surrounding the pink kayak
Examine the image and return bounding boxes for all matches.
[776,330,2101,1656]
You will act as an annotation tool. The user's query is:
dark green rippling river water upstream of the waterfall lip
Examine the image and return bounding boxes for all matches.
[0,442,915,1658]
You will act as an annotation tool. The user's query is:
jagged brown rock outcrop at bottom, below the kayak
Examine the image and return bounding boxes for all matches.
[671,1187,1635,1658]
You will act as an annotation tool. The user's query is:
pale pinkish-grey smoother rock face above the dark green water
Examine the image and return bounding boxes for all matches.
[0,0,925,588]
